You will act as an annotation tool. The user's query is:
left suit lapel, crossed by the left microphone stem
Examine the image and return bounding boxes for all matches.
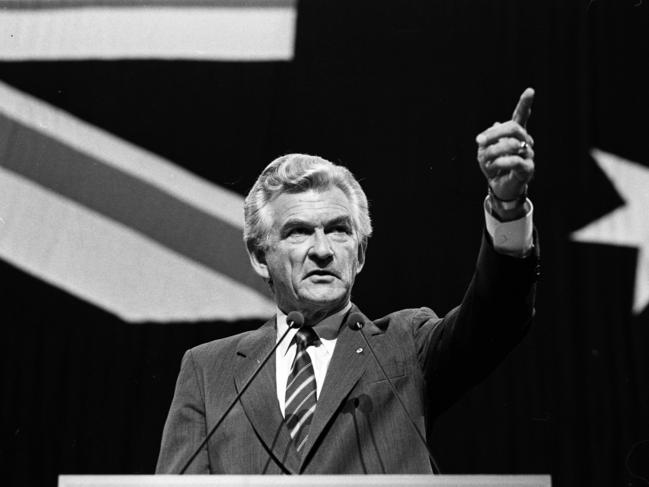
[235,319,300,474]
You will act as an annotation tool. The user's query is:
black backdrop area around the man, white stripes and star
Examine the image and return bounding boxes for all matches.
[0,0,649,487]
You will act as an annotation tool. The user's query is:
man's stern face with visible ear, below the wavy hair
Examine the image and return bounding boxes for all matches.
[252,187,364,320]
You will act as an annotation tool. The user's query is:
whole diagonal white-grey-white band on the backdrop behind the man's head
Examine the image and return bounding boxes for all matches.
[0,83,274,322]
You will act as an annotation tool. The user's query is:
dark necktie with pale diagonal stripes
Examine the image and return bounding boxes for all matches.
[284,326,318,452]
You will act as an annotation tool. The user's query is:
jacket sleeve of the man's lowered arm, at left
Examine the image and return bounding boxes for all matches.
[156,350,209,474]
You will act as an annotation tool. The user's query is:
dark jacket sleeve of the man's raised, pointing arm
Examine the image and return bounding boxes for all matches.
[412,231,539,416]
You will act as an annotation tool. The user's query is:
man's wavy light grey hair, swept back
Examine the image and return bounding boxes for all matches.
[243,154,372,251]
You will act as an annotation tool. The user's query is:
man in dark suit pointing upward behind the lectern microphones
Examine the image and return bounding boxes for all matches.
[157,89,537,474]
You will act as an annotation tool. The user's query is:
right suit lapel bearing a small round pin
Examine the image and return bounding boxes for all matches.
[300,306,380,469]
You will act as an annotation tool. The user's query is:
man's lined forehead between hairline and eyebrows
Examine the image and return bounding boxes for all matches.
[268,187,352,225]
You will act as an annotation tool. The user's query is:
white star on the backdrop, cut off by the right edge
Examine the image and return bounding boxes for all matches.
[572,149,649,313]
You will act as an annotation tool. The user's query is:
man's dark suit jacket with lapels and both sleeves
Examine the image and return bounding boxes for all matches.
[156,237,538,474]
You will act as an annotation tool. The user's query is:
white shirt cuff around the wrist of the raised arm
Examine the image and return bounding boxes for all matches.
[484,196,534,257]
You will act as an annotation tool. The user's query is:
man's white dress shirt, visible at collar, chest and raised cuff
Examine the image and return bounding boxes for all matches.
[275,197,533,416]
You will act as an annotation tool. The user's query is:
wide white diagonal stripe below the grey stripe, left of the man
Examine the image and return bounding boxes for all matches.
[0,167,274,322]
